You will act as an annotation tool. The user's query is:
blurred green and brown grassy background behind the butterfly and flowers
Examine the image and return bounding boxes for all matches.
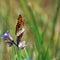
[0,0,60,60]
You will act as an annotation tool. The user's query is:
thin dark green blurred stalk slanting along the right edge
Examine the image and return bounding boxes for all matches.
[50,0,60,45]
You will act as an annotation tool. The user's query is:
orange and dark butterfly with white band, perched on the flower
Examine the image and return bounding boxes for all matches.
[15,15,25,47]
